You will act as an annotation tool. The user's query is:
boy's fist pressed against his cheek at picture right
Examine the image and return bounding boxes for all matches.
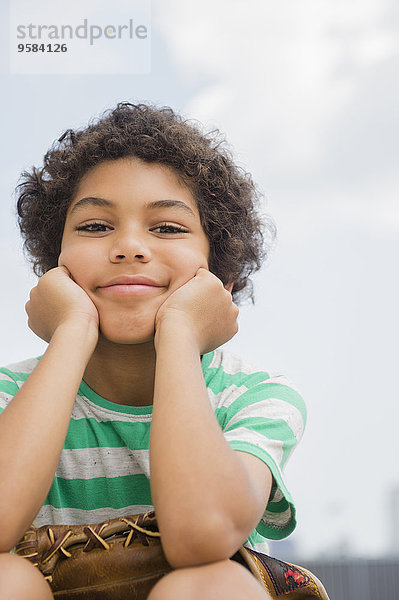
[154,268,238,354]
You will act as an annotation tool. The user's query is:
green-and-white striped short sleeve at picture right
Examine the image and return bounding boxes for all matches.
[205,350,306,549]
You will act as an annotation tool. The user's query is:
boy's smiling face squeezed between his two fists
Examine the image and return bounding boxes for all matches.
[59,159,209,344]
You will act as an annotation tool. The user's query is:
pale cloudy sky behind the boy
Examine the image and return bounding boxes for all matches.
[0,0,399,557]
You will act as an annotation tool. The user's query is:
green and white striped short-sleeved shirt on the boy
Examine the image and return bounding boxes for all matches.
[0,349,306,552]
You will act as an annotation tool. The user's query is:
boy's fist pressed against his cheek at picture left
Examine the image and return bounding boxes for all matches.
[25,266,99,342]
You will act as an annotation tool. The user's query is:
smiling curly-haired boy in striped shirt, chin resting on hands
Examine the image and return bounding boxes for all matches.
[0,103,305,600]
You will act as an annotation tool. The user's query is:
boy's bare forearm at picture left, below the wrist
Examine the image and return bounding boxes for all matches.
[0,322,96,550]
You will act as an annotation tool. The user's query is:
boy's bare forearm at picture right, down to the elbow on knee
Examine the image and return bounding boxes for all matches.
[150,330,260,566]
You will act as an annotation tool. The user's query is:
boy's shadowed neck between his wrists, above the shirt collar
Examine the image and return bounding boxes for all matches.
[83,334,156,406]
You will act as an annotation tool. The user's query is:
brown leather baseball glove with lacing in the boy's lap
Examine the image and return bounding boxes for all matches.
[15,512,328,600]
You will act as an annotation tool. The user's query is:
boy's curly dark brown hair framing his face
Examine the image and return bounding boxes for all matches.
[17,102,276,301]
